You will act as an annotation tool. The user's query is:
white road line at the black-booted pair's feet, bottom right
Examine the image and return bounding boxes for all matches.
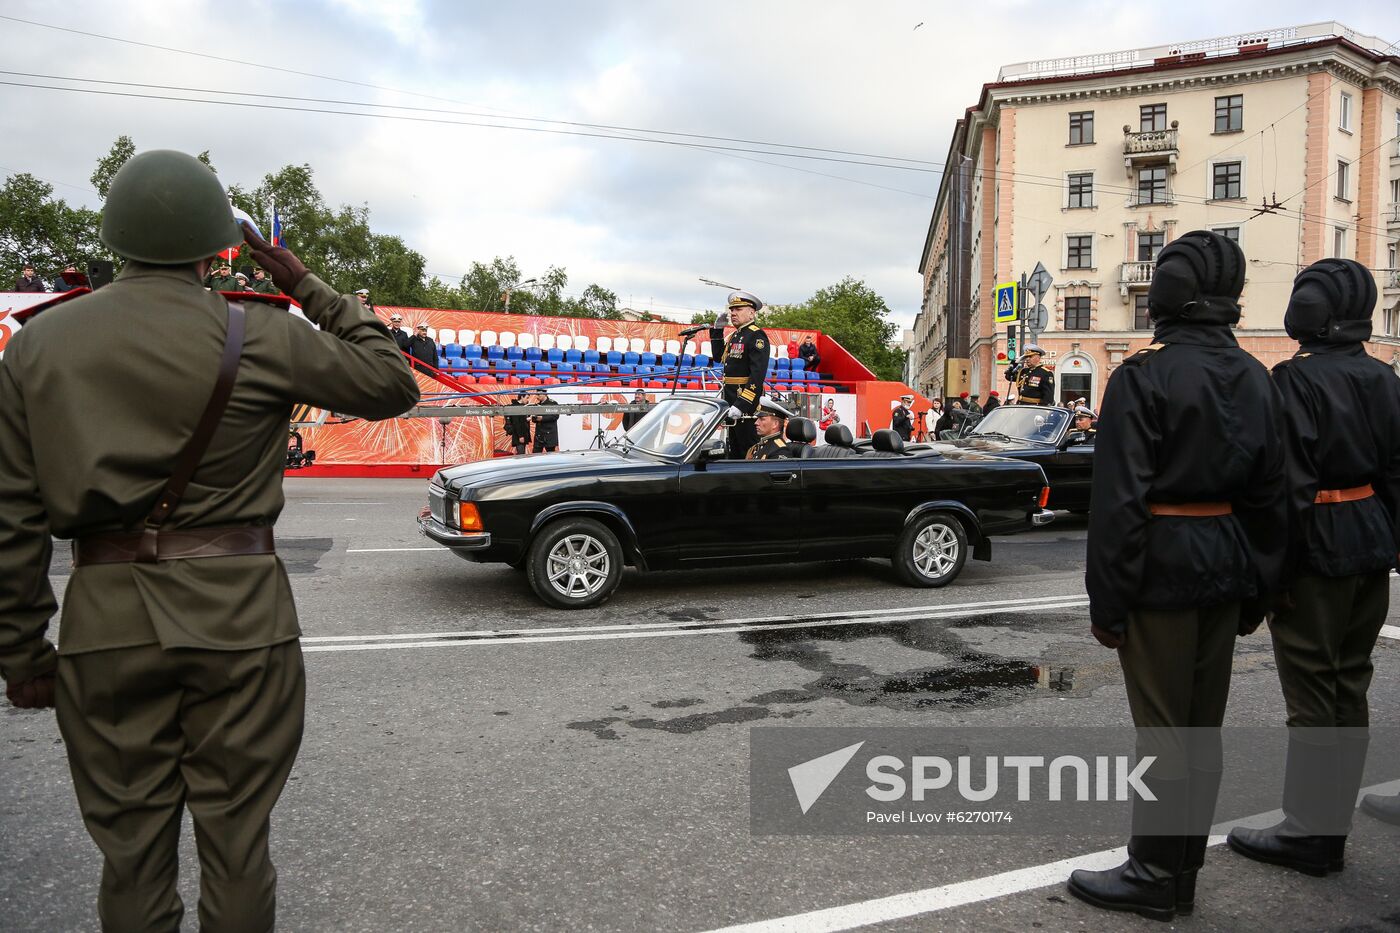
[710,780,1400,933]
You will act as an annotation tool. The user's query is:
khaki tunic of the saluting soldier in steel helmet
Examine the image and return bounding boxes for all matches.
[0,262,419,682]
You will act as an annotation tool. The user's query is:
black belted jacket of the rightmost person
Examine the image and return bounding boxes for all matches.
[1274,343,1400,574]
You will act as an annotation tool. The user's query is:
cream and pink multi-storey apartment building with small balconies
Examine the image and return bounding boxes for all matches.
[910,22,1400,403]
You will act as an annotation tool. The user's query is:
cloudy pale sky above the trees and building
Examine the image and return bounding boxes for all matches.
[0,0,1400,326]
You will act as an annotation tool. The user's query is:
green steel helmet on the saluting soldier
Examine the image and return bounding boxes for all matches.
[102,148,244,266]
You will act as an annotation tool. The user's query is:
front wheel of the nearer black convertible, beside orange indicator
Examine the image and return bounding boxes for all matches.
[525,518,622,609]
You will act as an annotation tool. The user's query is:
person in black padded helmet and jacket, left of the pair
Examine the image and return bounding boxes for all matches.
[1070,231,1288,920]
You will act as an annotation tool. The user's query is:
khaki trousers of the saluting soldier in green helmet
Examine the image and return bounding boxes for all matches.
[57,642,305,933]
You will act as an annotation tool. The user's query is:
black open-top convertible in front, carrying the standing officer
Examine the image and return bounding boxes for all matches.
[419,396,1053,608]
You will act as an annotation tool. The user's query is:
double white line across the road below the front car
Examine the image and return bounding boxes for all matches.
[301,597,1089,651]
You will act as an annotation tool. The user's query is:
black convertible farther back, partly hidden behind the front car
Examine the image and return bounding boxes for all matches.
[928,405,1093,511]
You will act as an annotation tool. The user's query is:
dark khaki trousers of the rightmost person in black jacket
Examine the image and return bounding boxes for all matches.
[1268,570,1390,727]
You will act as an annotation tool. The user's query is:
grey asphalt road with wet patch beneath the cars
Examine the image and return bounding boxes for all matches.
[0,479,1400,932]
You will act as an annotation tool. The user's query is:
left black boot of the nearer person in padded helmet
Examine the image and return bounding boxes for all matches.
[1070,779,1194,920]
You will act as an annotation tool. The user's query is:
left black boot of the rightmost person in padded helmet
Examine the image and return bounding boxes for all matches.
[1225,730,1340,877]
